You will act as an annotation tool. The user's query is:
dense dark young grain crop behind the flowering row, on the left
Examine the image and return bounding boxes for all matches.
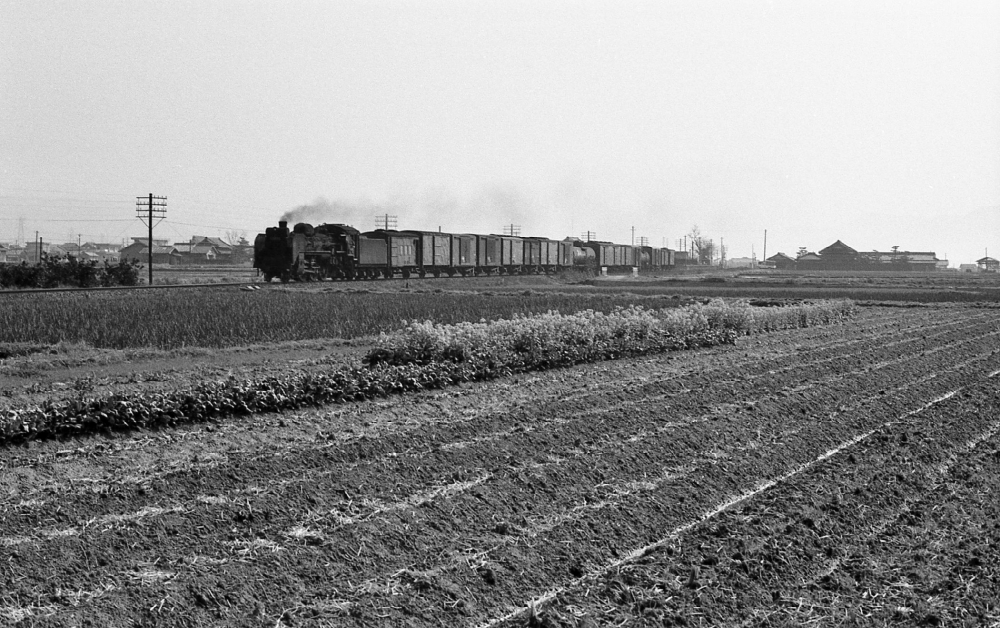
[0,289,708,349]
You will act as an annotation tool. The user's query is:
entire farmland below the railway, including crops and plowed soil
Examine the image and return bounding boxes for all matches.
[0,274,1000,628]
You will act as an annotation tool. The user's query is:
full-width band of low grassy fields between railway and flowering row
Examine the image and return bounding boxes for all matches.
[0,271,1000,349]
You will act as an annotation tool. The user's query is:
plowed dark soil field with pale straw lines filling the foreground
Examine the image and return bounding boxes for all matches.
[0,307,1000,627]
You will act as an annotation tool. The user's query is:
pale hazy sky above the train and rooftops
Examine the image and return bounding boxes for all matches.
[0,0,1000,265]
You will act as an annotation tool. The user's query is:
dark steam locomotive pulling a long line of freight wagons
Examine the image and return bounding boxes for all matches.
[253,221,674,282]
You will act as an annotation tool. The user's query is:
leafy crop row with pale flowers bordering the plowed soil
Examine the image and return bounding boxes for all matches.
[0,302,852,442]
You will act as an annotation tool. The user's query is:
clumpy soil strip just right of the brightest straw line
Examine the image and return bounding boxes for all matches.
[516,376,1000,625]
